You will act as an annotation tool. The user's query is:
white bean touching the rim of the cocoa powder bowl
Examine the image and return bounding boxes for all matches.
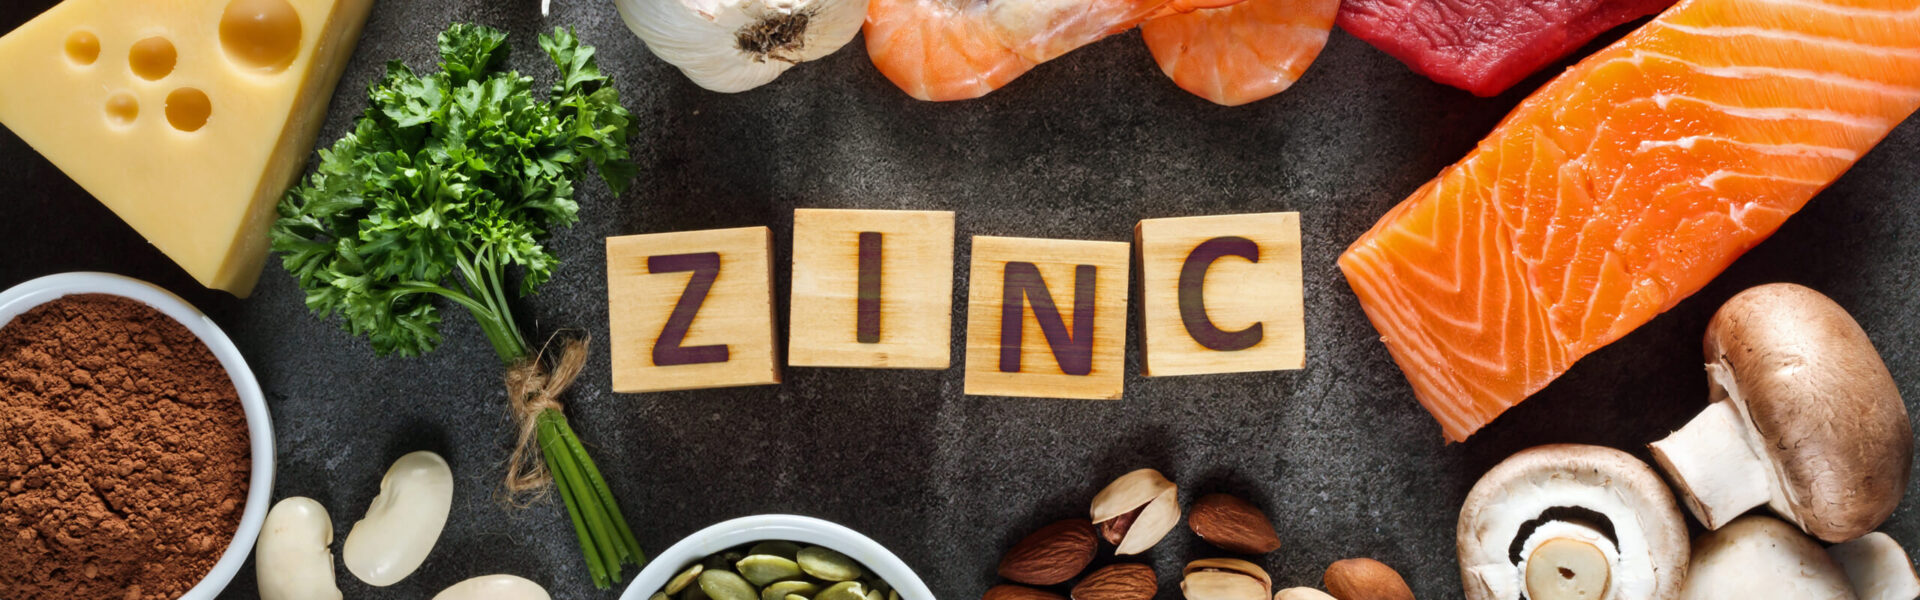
[253,496,340,600]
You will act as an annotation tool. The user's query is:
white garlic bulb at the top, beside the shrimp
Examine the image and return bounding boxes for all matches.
[614,0,868,92]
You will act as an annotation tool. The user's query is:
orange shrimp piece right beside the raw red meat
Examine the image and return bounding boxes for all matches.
[1140,0,1340,106]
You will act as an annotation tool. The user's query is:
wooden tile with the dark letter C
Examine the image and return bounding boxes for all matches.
[1133,213,1306,377]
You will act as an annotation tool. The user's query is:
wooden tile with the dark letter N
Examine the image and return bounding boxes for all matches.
[966,237,1129,400]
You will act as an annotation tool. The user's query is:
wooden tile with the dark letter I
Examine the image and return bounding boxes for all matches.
[787,208,954,369]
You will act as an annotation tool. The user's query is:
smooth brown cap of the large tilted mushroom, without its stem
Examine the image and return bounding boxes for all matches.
[1705,283,1912,542]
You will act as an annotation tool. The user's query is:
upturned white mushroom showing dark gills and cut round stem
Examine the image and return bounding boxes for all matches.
[1457,444,1688,600]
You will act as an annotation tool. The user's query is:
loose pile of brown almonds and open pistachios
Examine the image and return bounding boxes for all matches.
[983,469,1413,600]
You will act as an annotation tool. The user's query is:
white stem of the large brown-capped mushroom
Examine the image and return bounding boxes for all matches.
[1651,396,1772,529]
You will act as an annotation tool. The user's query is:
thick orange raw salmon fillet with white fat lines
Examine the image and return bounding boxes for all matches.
[1340,0,1920,440]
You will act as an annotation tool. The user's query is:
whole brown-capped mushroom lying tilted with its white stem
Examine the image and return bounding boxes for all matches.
[1653,283,1912,542]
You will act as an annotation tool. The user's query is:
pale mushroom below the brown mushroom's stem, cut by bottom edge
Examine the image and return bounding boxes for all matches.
[1680,515,1855,600]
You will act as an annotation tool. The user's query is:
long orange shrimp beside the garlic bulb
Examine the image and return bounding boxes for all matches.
[866,0,1242,102]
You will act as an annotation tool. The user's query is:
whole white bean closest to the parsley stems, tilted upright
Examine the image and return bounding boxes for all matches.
[340,450,453,587]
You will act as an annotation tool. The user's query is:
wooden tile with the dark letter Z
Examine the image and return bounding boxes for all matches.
[607,227,780,392]
